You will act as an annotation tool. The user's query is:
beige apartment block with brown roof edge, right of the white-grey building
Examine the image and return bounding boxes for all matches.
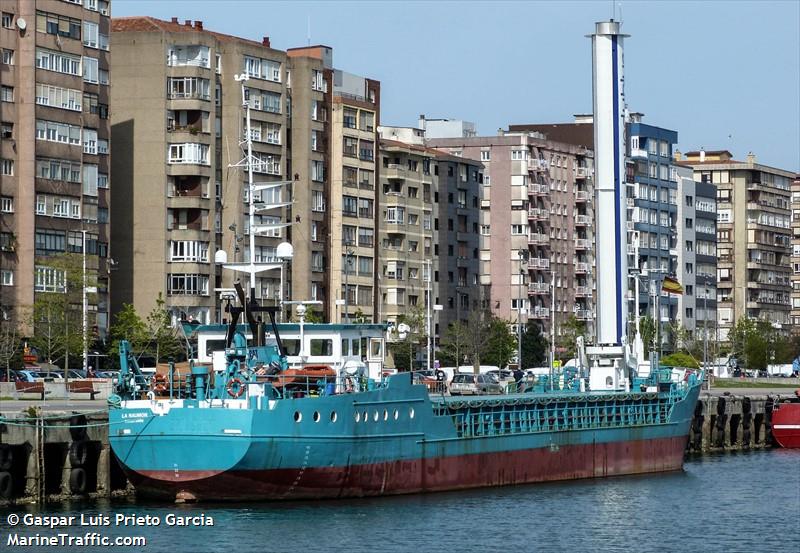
[681,150,795,341]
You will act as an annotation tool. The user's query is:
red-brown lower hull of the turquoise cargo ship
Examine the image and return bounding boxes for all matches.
[128,437,687,501]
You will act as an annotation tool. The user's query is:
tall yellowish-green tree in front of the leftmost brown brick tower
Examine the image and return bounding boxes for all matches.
[28,254,91,369]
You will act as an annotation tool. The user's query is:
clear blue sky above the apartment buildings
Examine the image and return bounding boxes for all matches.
[112,0,800,172]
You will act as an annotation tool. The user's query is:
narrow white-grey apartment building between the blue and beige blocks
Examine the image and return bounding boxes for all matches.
[673,165,717,341]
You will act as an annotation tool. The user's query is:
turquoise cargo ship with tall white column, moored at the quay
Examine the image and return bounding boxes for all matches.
[104,20,702,501]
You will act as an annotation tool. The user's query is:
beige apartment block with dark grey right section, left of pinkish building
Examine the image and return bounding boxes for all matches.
[377,126,482,348]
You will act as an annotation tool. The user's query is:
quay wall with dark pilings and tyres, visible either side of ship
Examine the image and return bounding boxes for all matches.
[0,392,793,505]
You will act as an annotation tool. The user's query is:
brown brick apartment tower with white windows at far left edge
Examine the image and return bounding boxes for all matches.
[0,0,110,335]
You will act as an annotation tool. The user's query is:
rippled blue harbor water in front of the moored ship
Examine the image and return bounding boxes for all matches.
[0,449,800,553]
